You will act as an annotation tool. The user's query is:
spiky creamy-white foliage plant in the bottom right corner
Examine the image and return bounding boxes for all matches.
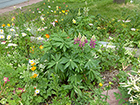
[120,70,140,105]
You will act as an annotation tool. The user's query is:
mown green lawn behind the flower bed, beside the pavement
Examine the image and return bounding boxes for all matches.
[0,0,140,24]
